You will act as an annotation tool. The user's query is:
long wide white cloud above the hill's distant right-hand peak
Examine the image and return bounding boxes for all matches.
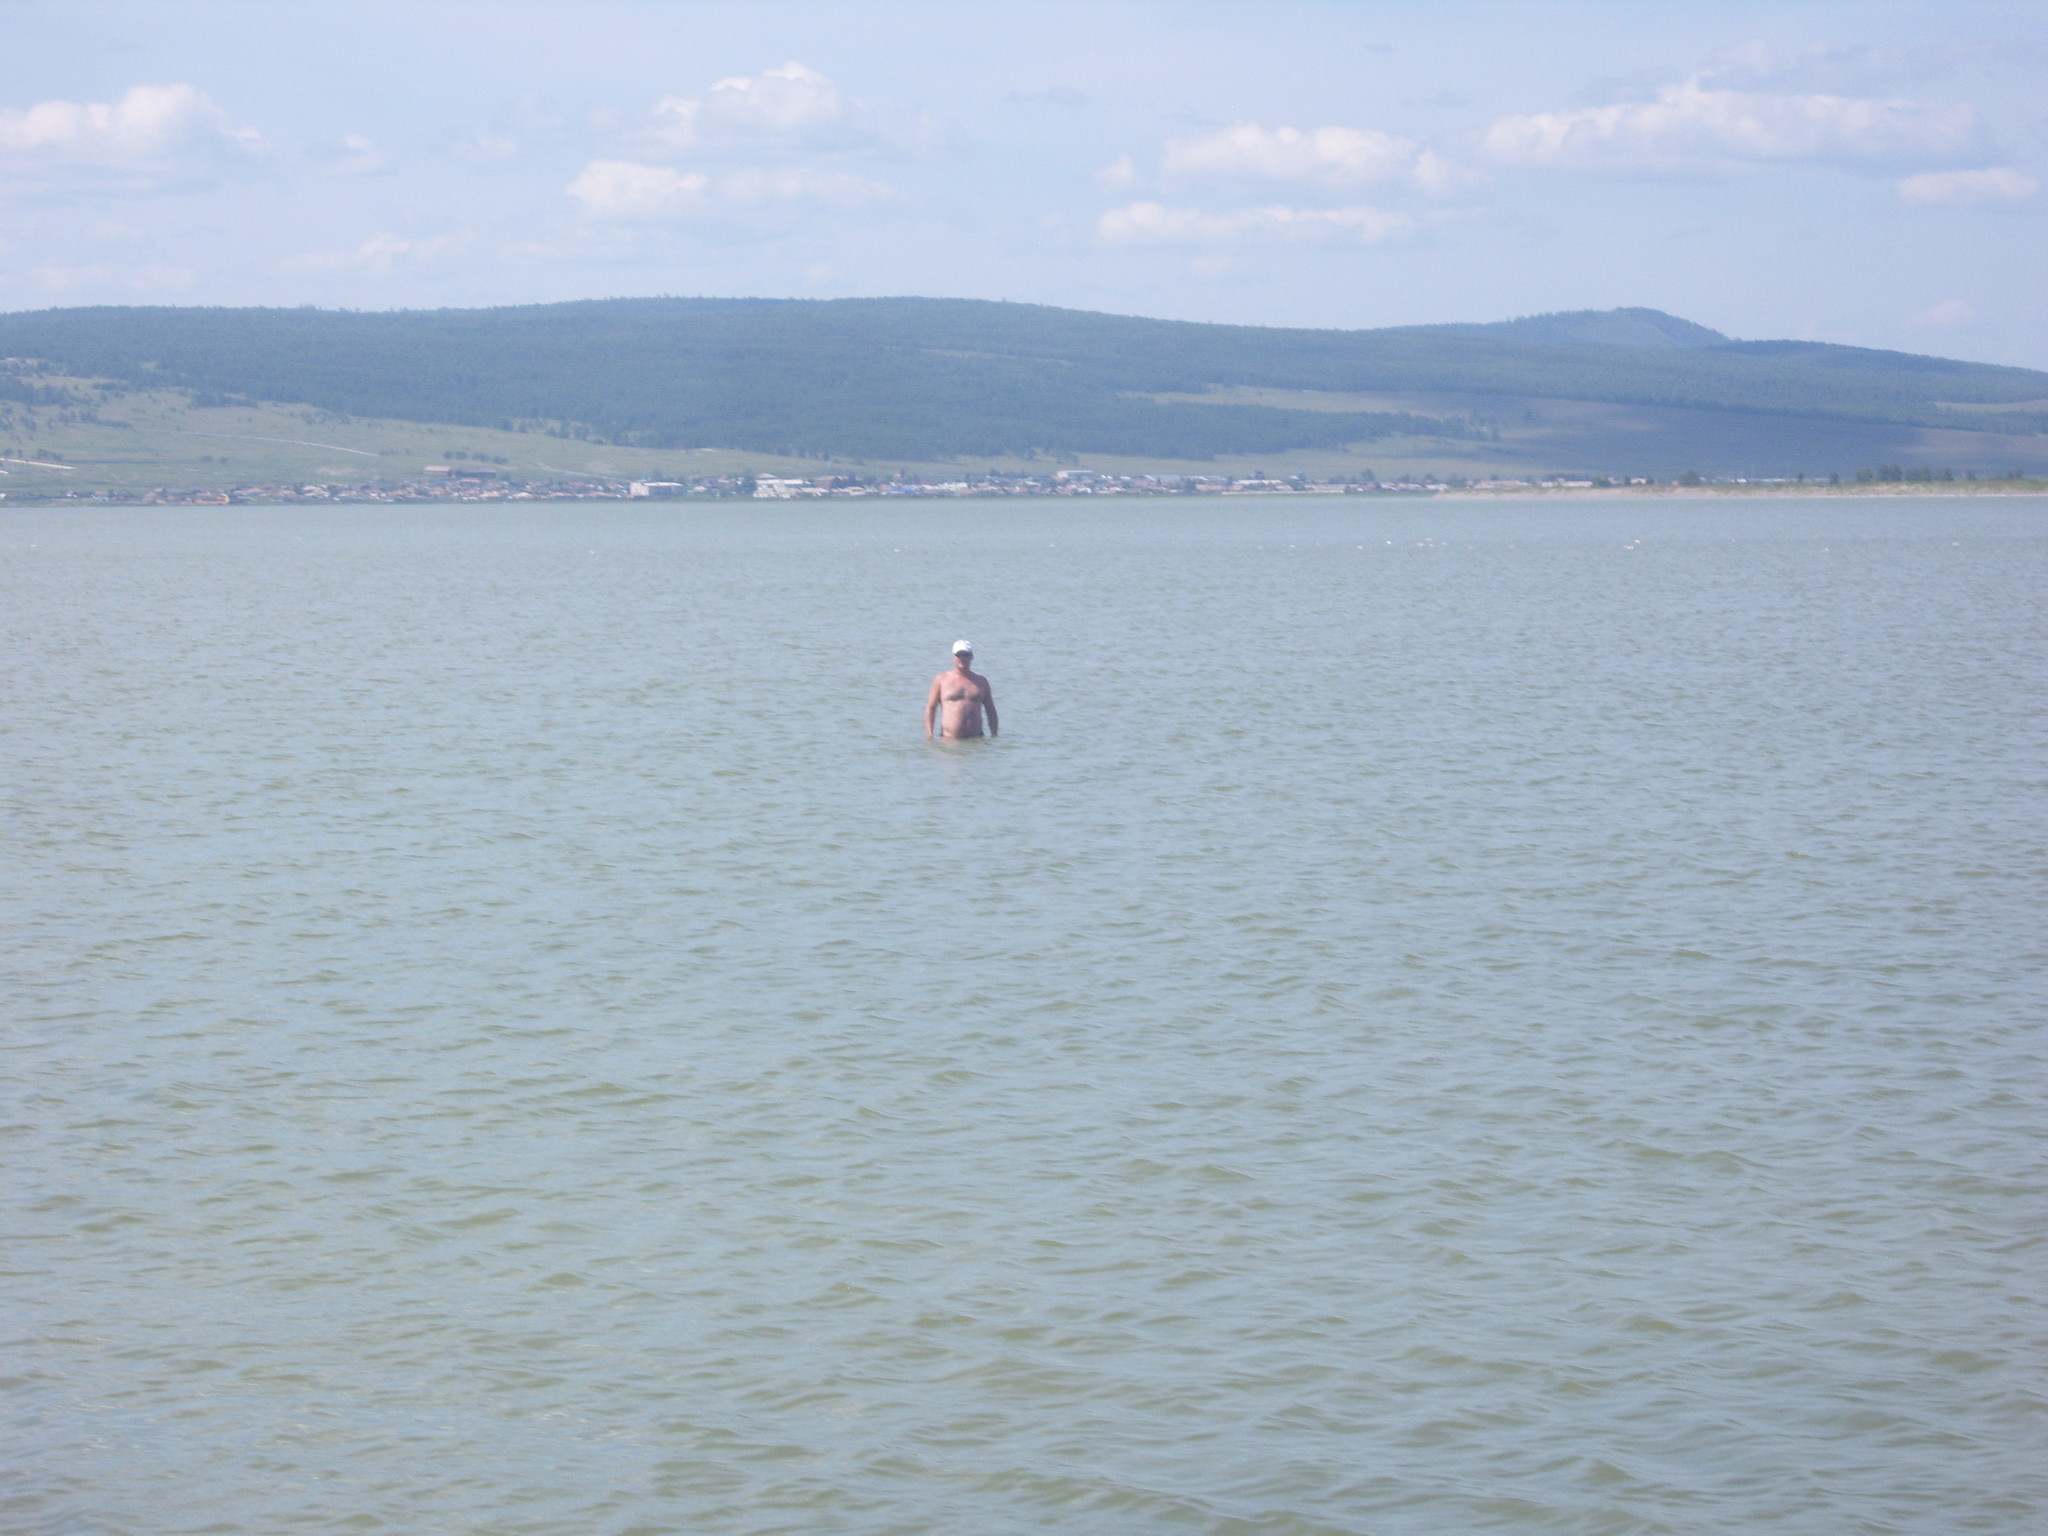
[1483,78,1976,170]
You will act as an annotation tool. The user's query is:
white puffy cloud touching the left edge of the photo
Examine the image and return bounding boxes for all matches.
[0,84,262,188]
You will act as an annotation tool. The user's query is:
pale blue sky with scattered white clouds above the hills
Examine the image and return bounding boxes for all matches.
[12,0,2048,369]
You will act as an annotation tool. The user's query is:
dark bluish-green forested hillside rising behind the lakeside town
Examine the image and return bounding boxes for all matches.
[0,299,2048,459]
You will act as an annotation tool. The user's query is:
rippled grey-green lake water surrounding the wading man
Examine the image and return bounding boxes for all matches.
[0,498,2048,1536]
